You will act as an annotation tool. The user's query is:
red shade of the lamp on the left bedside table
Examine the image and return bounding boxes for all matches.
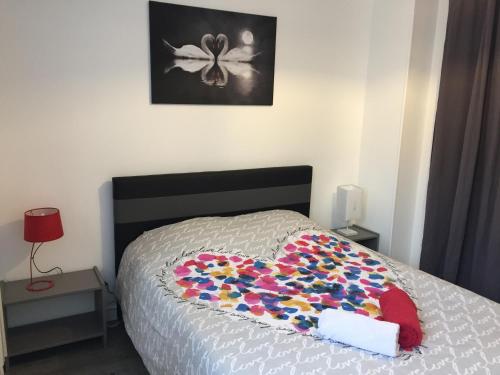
[24,207,64,242]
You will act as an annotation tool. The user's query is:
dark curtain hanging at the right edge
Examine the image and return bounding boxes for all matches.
[420,0,500,302]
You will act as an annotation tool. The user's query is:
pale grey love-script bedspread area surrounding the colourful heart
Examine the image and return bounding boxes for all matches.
[117,210,500,375]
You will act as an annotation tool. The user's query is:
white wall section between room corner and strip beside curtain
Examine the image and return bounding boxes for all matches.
[359,0,415,253]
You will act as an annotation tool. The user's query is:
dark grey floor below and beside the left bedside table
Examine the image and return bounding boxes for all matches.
[7,324,148,375]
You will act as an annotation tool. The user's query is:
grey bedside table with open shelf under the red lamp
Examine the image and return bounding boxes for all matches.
[0,267,107,367]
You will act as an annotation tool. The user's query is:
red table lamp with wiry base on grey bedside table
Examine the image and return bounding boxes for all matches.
[24,207,64,292]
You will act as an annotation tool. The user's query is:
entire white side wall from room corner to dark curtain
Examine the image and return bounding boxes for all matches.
[359,0,448,258]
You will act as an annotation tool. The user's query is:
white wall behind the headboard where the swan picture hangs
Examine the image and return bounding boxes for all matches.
[0,0,372,300]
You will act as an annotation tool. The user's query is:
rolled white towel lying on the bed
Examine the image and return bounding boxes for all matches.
[318,309,399,357]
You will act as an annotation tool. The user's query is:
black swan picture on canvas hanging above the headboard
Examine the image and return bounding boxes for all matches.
[149,1,277,105]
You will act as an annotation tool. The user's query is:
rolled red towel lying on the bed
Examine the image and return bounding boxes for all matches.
[379,288,422,349]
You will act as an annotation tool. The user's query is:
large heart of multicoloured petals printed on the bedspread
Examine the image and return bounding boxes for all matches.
[174,231,394,333]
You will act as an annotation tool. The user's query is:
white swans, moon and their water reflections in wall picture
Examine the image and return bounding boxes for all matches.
[163,31,260,95]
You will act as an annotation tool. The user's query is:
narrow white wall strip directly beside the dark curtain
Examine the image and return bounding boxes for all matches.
[391,0,448,267]
